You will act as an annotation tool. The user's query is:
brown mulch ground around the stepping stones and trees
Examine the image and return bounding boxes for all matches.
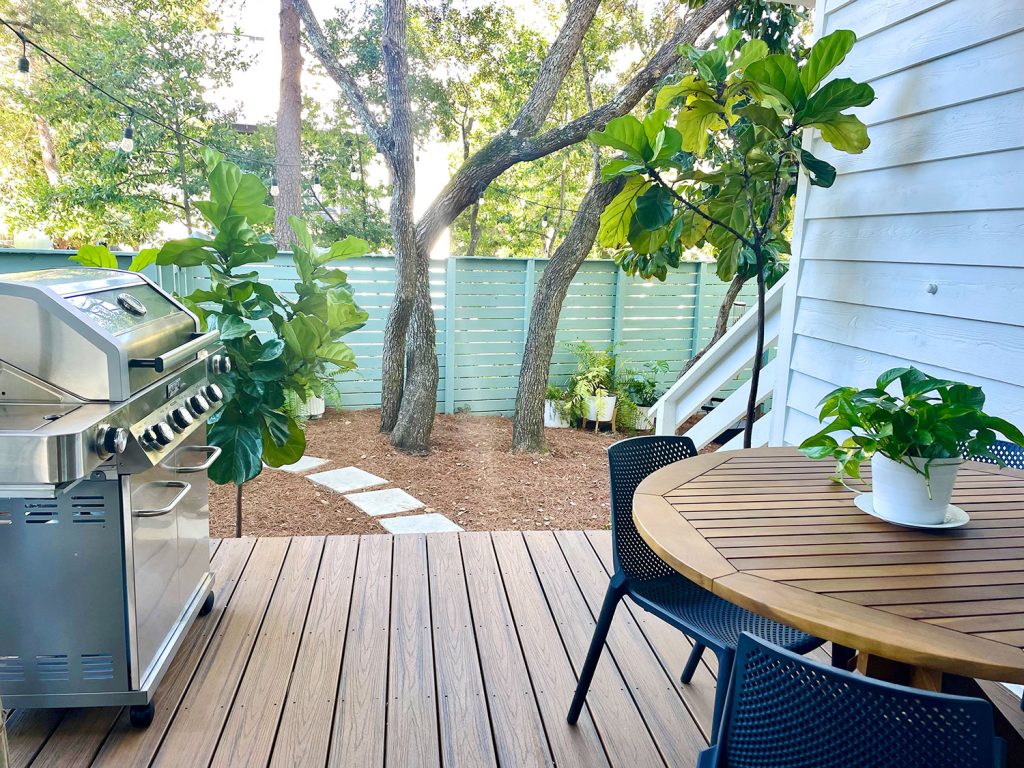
[210,410,712,537]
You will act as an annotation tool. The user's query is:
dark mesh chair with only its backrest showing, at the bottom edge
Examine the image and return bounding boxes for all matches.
[697,634,1006,768]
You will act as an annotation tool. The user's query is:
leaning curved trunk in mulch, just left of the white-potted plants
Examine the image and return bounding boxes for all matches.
[512,177,625,453]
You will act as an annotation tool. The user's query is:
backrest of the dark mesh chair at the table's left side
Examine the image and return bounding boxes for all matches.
[608,435,697,579]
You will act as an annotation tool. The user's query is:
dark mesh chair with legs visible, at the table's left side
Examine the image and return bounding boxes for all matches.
[567,435,822,743]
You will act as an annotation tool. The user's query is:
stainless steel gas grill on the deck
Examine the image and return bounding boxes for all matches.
[0,268,230,725]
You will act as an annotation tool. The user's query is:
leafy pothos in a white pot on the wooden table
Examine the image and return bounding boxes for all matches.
[800,367,1024,525]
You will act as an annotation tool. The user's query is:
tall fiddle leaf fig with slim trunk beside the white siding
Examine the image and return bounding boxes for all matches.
[590,30,874,447]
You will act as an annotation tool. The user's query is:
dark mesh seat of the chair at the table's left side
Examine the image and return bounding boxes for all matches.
[627,573,823,653]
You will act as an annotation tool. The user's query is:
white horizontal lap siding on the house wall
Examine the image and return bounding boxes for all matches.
[771,0,1024,444]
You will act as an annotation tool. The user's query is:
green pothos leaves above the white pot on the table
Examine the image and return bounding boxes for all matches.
[800,368,1024,478]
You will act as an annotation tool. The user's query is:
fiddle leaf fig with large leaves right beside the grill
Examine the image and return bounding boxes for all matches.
[157,151,369,536]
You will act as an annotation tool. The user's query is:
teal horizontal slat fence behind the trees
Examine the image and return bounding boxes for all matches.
[0,249,754,416]
